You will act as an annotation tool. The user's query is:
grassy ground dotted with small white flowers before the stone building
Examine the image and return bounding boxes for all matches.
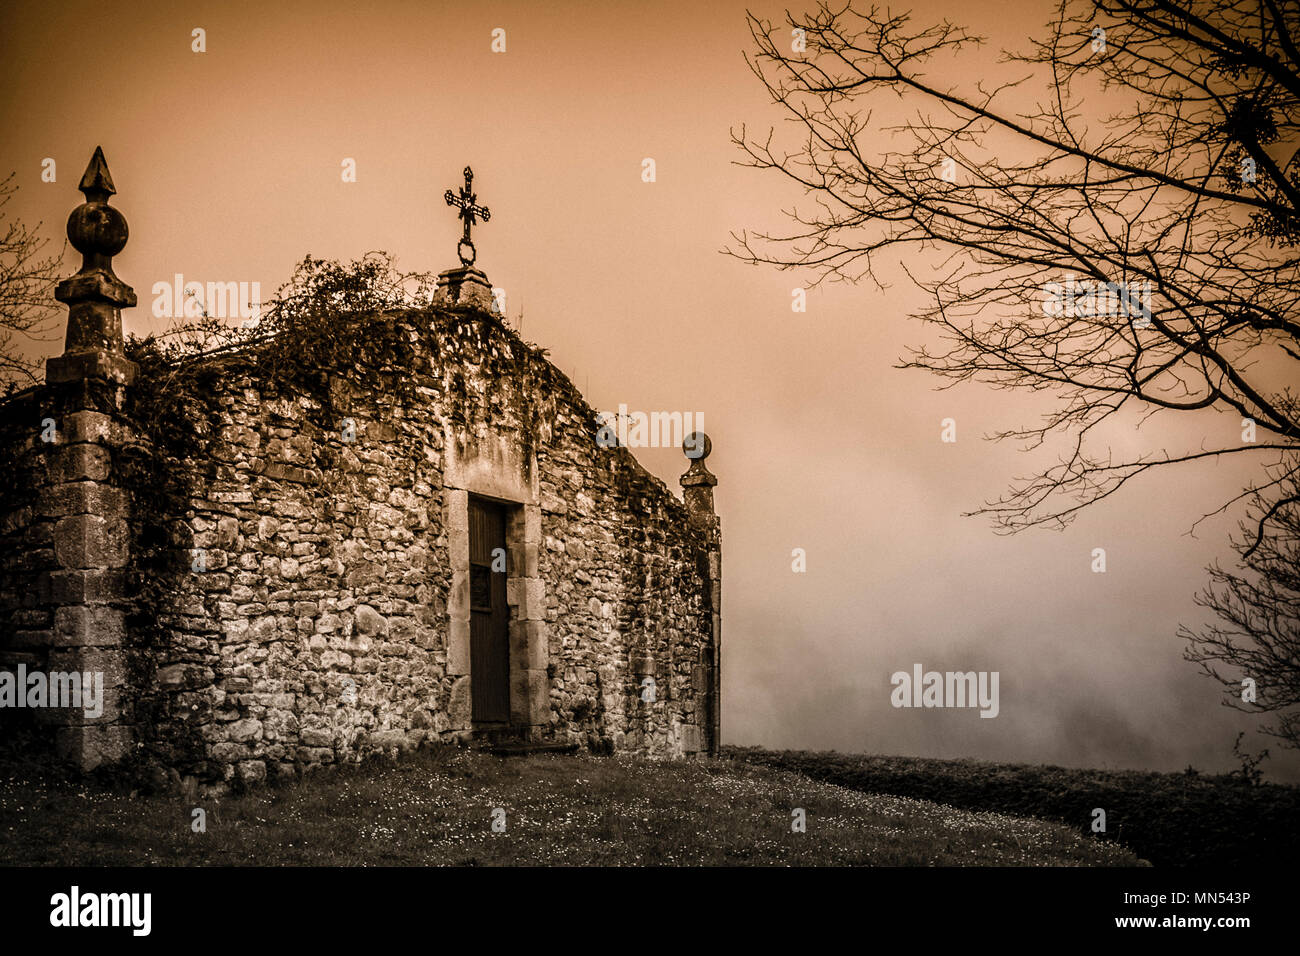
[0,749,1140,866]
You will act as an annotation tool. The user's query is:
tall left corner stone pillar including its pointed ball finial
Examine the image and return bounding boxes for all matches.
[40,148,137,770]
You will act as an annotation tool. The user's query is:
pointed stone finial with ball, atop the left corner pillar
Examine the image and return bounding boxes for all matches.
[46,147,137,385]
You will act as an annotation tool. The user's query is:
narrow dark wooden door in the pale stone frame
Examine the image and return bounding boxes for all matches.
[469,498,510,723]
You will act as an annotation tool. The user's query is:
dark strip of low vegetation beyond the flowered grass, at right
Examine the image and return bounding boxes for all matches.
[724,748,1300,866]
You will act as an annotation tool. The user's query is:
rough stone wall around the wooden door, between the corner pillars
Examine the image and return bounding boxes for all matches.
[10,308,718,788]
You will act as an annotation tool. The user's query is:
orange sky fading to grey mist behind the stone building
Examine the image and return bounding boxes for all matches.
[0,0,1300,782]
